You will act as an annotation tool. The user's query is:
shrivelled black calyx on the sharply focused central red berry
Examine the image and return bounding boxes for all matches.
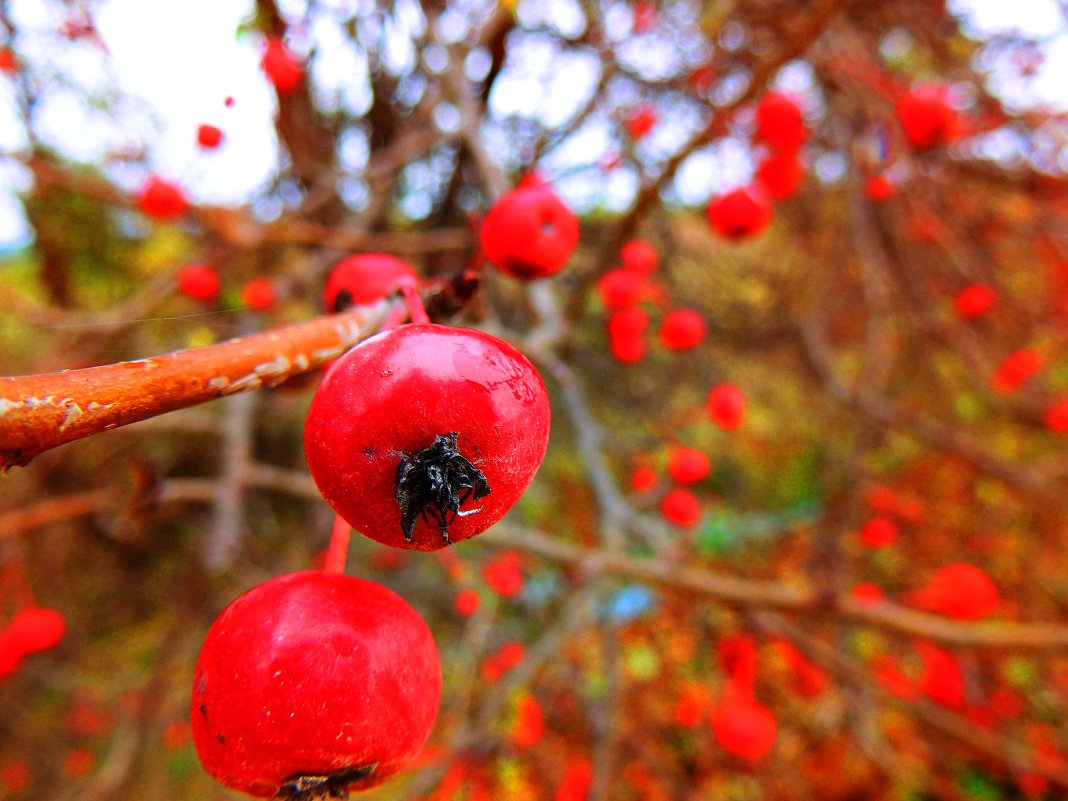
[394,431,490,544]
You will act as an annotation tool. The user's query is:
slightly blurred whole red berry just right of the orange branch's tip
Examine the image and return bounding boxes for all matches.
[480,180,579,280]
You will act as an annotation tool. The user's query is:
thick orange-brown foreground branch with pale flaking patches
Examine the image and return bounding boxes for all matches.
[0,302,388,471]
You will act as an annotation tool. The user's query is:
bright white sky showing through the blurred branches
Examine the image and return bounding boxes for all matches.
[0,0,1068,249]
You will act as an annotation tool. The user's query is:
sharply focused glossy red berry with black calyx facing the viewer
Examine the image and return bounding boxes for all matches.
[304,324,549,551]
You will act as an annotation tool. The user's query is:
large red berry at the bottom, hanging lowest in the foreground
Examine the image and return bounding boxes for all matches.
[190,570,441,801]
